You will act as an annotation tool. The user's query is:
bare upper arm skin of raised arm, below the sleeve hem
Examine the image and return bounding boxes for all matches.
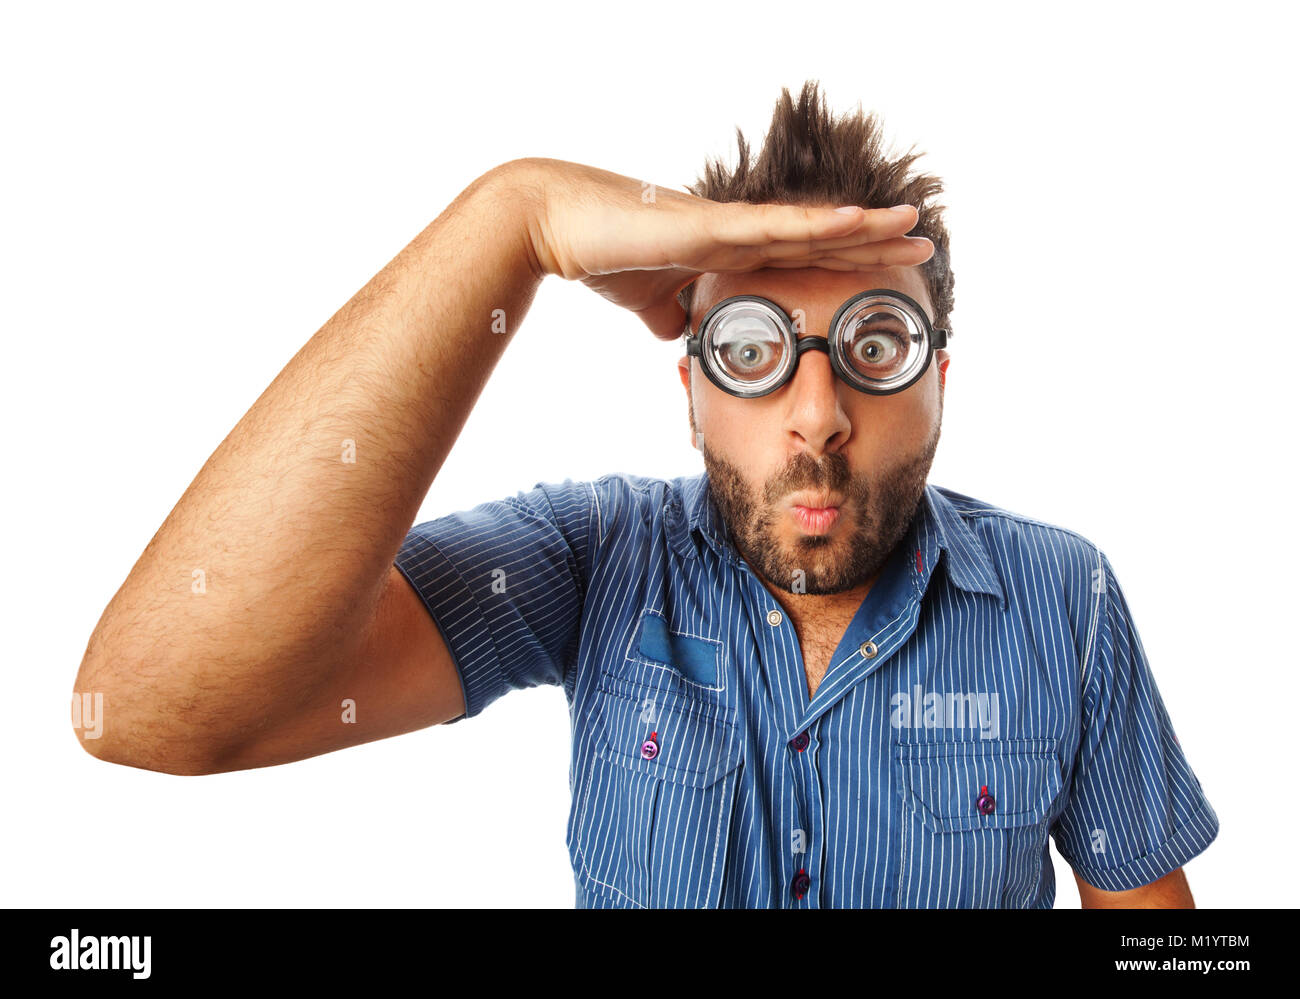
[207,566,465,773]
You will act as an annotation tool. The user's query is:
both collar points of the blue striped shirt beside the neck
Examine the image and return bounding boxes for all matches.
[667,472,1006,610]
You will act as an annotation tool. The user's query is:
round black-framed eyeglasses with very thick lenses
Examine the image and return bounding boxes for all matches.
[686,287,952,399]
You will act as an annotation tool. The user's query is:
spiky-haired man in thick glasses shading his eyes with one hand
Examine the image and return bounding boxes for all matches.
[77,83,1218,908]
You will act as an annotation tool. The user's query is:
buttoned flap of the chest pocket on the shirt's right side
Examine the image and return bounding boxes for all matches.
[894,739,1061,833]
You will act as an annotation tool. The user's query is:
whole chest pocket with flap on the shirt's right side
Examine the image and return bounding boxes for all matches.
[894,739,1061,908]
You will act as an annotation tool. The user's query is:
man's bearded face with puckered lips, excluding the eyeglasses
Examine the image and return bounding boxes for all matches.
[677,267,948,594]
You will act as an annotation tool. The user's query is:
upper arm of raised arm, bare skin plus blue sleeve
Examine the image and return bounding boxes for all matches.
[204,480,598,773]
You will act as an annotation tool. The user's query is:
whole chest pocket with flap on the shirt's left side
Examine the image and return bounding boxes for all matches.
[568,676,742,908]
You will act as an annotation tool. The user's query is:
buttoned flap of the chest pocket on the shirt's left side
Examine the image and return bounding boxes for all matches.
[593,676,742,787]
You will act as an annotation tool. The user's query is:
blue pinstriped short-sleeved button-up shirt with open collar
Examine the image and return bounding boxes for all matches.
[397,473,1218,908]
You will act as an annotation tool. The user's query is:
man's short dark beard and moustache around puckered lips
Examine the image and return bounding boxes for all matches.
[690,408,943,594]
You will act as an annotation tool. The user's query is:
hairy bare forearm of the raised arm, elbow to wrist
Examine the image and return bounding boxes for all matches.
[75,164,541,766]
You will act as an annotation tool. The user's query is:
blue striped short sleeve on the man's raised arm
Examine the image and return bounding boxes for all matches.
[394,479,599,721]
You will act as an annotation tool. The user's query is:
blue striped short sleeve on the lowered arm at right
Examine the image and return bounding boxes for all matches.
[1053,552,1218,891]
